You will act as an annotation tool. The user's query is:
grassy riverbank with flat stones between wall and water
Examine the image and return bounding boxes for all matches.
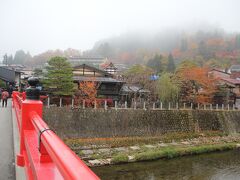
[65,131,240,166]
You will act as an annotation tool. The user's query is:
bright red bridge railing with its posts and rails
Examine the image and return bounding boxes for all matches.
[13,92,99,180]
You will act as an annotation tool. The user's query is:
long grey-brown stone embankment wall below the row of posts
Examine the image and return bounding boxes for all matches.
[43,107,240,138]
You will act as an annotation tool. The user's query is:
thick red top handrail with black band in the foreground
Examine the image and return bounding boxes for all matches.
[31,112,98,179]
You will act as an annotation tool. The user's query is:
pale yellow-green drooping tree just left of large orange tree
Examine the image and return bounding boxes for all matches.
[157,73,180,104]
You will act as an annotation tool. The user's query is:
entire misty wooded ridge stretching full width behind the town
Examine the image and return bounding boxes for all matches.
[3,26,240,68]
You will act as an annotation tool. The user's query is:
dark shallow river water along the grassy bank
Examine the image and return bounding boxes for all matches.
[92,150,240,180]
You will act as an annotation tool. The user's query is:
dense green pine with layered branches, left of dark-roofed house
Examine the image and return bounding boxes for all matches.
[44,56,74,96]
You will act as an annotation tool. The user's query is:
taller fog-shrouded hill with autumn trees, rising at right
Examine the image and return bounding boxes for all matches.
[90,27,240,64]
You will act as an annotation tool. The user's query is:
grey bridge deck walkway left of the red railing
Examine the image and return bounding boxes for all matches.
[0,100,15,180]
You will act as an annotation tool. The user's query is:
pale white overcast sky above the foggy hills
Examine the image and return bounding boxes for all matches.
[0,0,240,59]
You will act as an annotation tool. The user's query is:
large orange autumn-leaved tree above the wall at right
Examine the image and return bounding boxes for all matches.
[177,66,217,104]
